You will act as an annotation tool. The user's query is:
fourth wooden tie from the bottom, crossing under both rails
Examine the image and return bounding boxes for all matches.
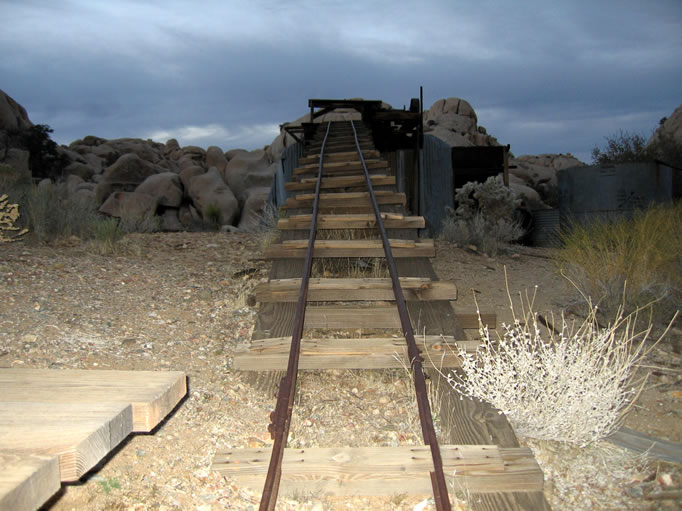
[254,277,457,302]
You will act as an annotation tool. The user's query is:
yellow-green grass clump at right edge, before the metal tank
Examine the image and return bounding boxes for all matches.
[557,202,682,322]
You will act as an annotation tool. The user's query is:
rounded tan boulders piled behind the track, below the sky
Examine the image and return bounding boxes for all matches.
[0,91,582,231]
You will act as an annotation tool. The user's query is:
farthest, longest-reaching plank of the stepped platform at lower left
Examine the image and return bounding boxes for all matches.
[0,369,187,432]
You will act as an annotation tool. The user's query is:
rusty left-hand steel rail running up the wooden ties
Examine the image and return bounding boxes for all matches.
[259,121,332,511]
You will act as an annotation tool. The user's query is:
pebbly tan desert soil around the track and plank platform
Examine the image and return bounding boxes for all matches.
[0,233,682,511]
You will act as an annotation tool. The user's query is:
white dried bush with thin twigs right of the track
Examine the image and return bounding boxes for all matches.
[448,292,668,446]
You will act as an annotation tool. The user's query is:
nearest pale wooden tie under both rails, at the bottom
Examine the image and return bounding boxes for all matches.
[212,445,543,496]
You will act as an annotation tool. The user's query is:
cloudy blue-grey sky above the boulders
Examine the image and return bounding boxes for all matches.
[0,0,682,161]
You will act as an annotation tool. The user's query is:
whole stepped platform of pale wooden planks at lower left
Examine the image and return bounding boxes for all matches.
[0,369,187,510]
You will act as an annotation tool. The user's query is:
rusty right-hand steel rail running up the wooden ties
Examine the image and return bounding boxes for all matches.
[350,121,451,511]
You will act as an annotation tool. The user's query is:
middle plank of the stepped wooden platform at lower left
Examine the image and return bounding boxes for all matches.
[0,402,133,481]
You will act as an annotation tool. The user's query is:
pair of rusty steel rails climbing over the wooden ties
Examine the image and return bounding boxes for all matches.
[260,121,450,511]
